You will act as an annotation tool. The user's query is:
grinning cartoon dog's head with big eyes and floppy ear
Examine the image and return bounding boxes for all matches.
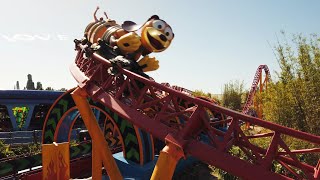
[122,15,174,52]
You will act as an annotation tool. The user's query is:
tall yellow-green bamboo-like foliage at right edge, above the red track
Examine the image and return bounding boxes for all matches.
[264,35,320,135]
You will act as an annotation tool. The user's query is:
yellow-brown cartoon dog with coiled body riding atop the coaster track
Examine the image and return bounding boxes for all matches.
[85,8,174,72]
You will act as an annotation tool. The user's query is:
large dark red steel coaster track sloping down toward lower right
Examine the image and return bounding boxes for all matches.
[70,43,320,179]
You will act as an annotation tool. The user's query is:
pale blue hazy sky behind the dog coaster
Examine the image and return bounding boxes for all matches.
[0,0,320,94]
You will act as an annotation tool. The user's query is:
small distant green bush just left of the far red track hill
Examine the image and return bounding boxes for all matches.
[222,81,247,111]
